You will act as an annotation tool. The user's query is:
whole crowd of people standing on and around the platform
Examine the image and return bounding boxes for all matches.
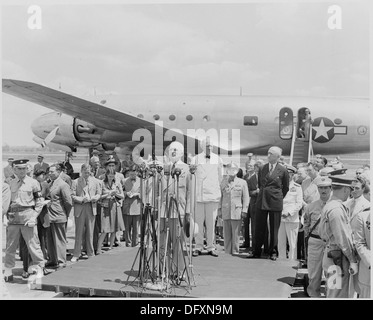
[3,146,370,298]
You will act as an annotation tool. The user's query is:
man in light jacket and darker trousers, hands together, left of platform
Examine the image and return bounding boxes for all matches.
[71,164,102,262]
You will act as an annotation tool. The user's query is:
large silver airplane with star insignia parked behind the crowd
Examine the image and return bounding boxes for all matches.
[3,79,370,164]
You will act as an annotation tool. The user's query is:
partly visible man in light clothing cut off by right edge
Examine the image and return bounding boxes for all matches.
[354,208,372,299]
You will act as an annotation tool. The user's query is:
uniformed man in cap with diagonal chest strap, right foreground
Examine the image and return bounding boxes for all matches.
[304,177,332,298]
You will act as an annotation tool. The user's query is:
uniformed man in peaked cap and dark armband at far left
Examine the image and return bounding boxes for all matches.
[4,159,45,281]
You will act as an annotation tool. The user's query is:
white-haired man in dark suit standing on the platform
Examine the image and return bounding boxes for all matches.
[248,147,289,260]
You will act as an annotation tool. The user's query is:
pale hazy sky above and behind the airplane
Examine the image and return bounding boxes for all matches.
[1,1,370,145]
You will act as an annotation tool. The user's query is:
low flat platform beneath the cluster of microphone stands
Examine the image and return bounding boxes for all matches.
[38,247,295,299]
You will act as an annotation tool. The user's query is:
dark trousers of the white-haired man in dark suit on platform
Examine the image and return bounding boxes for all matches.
[254,209,281,256]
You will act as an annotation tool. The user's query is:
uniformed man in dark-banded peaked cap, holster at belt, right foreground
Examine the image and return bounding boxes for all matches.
[319,174,358,298]
